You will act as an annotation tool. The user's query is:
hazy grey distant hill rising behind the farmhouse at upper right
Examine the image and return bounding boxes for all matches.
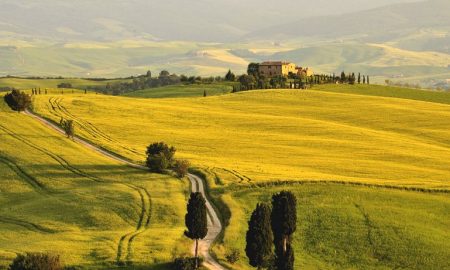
[247,0,450,42]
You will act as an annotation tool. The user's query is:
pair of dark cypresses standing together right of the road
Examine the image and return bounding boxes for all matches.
[245,191,297,270]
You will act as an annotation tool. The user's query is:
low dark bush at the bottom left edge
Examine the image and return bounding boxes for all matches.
[9,253,64,270]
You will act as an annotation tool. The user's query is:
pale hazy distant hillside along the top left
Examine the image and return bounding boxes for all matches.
[0,0,422,42]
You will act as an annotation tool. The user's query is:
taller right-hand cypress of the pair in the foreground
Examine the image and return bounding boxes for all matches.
[271,191,297,270]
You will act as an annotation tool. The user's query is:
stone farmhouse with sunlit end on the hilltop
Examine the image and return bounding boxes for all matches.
[258,61,312,77]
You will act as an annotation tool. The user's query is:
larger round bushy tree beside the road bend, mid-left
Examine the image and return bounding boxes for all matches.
[146,142,176,173]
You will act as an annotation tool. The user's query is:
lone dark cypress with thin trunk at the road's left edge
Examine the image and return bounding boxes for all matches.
[184,192,208,268]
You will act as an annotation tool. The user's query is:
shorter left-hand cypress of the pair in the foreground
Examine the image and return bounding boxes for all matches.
[245,203,273,269]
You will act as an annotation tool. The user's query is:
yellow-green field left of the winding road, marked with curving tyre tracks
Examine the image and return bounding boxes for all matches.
[0,97,190,269]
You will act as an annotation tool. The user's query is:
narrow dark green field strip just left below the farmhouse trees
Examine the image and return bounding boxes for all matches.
[124,83,237,98]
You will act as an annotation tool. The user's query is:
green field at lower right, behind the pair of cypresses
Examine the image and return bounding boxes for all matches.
[214,184,450,269]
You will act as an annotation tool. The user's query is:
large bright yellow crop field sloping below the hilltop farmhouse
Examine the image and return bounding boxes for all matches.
[34,86,450,189]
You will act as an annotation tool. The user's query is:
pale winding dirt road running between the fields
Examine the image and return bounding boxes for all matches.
[24,110,225,270]
